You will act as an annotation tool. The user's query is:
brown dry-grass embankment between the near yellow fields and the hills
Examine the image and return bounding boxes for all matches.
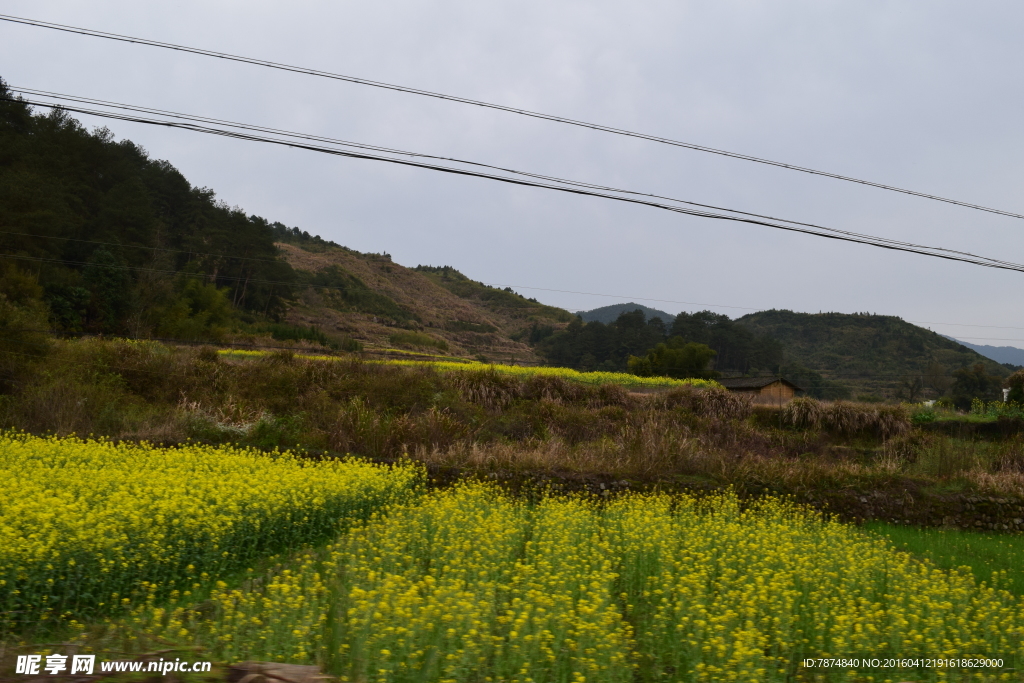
[6,340,1024,495]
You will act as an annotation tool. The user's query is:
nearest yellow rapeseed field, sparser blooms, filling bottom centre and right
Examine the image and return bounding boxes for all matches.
[126,484,1024,683]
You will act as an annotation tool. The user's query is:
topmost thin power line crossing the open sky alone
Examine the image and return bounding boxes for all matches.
[0,14,1024,218]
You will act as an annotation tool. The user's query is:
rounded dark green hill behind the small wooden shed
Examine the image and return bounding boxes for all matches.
[735,310,1011,399]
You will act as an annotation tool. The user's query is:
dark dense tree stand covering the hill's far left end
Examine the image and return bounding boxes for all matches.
[0,81,295,336]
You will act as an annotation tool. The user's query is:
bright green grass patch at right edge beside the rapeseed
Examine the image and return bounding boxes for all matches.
[864,522,1024,595]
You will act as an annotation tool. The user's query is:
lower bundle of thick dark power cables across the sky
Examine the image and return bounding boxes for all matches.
[12,94,1024,272]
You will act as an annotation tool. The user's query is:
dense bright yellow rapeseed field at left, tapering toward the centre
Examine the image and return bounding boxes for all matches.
[0,433,419,632]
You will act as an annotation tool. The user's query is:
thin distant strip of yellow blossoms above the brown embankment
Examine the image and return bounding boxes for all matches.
[220,350,721,388]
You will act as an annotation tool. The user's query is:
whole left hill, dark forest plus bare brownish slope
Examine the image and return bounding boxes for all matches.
[0,81,572,361]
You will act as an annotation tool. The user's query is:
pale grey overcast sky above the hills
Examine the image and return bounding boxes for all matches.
[0,0,1024,347]
